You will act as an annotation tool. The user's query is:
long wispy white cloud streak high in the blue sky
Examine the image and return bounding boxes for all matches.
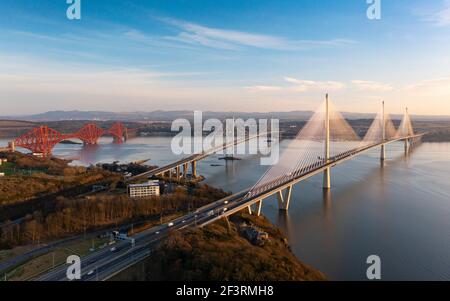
[160,18,354,50]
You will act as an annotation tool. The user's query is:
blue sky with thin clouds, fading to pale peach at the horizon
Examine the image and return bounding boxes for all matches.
[0,0,450,116]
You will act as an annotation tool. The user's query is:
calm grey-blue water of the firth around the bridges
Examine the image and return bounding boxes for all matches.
[2,137,450,280]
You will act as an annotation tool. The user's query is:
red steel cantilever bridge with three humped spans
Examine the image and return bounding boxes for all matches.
[11,122,128,156]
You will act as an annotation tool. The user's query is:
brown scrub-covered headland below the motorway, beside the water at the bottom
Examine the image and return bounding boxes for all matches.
[113,213,326,281]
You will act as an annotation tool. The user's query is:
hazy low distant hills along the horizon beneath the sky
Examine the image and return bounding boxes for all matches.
[0,110,450,122]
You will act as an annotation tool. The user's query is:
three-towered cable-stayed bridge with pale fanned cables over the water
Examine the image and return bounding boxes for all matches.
[199,95,426,225]
